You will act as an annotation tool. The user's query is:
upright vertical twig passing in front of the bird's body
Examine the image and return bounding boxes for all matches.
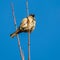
[26,0,30,60]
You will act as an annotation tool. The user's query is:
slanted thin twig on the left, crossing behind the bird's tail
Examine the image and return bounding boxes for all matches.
[11,3,24,60]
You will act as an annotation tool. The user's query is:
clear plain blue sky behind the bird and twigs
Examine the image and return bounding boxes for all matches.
[0,0,60,60]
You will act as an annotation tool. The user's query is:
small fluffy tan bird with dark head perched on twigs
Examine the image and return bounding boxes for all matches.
[10,14,36,38]
